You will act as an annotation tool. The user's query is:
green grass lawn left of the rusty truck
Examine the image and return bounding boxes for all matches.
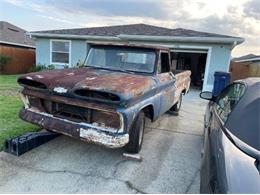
[0,75,40,151]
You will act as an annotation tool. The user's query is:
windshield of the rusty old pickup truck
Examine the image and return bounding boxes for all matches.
[86,46,156,73]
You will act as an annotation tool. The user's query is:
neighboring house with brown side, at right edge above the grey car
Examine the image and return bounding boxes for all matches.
[230,54,260,81]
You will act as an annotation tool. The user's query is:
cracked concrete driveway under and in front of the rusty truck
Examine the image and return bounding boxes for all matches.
[0,90,206,193]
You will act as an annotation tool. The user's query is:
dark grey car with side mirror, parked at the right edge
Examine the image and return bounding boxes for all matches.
[200,78,260,193]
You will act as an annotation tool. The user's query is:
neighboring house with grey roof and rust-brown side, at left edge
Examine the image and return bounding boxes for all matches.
[0,21,35,74]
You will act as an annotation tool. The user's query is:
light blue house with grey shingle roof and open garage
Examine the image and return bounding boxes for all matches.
[29,24,244,90]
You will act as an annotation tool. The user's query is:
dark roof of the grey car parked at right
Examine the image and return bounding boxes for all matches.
[225,78,260,151]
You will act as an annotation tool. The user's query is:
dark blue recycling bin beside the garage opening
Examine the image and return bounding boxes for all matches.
[212,72,231,97]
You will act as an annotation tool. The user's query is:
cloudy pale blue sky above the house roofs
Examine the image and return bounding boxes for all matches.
[0,0,260,57]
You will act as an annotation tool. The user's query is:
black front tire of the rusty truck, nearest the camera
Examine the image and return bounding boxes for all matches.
[125,111,145,153]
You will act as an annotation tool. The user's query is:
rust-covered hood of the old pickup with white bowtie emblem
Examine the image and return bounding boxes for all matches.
[18,67,156,101]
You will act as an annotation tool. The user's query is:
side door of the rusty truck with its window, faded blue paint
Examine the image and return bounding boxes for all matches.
[157,51,175,114]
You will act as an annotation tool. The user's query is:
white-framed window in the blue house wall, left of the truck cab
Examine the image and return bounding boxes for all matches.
[51,40,71,64]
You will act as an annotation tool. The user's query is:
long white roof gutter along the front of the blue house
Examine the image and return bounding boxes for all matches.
[27,32,244,46]
